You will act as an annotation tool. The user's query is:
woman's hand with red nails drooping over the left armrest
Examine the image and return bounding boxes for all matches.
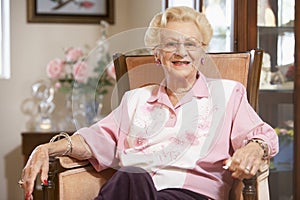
[20,144,49,200]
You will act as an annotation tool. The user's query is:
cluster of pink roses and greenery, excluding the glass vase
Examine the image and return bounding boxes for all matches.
[46,47,115,94]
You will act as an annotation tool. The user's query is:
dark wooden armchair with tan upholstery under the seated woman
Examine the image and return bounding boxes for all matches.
[43,50,269,200]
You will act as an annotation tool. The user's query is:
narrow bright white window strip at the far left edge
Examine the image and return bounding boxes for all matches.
[0,0,10,79]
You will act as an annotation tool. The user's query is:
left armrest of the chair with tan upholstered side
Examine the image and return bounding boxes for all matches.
[42,156,115,200]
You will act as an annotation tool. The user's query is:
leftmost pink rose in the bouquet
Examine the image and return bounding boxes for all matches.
[46,58,65,79]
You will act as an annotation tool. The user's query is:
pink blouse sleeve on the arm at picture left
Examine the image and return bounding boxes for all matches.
[75,95,129,171]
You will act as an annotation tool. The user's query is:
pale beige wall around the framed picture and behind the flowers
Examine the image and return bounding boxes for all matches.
[0,0,161,200]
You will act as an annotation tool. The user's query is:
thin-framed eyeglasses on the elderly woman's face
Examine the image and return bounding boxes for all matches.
[156,39,204,52]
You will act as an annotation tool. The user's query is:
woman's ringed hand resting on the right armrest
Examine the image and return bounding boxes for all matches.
[226,142,264,180]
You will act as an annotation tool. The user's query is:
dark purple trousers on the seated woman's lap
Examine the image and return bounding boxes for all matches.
[96,167,207,200]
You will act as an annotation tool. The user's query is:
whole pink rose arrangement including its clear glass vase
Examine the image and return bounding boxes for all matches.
[46,21,116,127]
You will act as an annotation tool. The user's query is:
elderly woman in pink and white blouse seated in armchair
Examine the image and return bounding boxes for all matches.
[21,7,278,200]
